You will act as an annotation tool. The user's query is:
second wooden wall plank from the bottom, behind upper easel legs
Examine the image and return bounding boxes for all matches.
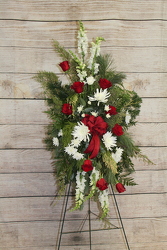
[0,193,167,221]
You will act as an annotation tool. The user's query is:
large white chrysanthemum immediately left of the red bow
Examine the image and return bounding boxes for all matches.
[72,122,89,141]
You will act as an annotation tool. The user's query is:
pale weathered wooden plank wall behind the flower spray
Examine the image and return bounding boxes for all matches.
[0,0,167,250]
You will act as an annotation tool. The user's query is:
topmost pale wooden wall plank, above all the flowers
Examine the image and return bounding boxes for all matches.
[0,0,165,21]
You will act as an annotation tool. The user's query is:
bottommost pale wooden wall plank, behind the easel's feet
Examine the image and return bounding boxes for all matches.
[0,218,167,250]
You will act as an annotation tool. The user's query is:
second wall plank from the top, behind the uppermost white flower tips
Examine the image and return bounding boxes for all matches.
[0,20,167,48]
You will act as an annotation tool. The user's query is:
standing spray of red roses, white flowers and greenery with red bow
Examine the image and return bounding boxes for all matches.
[35,22,151,218]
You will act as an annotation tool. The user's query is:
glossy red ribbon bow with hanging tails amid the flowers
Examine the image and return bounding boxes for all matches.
[81,115,108,159]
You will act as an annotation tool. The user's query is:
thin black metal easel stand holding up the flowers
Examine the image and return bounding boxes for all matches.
[56,184,130,250]
